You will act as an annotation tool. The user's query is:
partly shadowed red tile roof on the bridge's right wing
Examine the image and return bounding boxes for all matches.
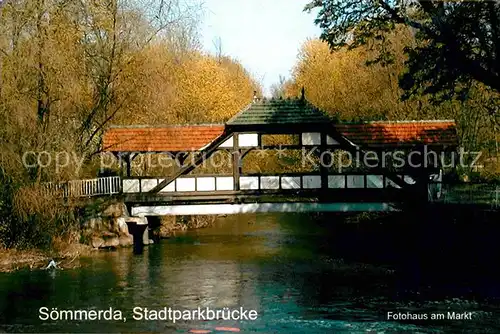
[335,121,458,147]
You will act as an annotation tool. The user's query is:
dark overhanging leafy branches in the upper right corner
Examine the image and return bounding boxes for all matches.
[305,0,500,101]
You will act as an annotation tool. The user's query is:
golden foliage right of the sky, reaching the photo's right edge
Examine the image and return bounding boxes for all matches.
[284,27,500,177]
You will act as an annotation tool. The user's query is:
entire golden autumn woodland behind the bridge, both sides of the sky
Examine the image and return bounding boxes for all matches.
[0,0,500,247]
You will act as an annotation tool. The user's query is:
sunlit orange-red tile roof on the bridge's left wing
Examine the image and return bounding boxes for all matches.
[103,124,224,152]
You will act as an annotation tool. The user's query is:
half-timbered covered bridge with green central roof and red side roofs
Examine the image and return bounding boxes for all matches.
[98,99,457,216]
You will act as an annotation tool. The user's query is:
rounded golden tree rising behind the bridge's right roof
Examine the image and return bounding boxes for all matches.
[286,34,438,121]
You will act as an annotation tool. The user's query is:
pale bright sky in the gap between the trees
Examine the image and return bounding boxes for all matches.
[198,0,320,94]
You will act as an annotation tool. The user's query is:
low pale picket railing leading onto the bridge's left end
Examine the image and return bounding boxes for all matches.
[43,176,122,197]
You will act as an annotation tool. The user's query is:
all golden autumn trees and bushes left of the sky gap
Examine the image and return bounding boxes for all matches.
[0,0,260,247]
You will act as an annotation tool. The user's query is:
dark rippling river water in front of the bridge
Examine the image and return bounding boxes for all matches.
[0,214,500,333]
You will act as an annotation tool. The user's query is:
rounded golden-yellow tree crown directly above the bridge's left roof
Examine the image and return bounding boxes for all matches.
[121,49,260,125]
